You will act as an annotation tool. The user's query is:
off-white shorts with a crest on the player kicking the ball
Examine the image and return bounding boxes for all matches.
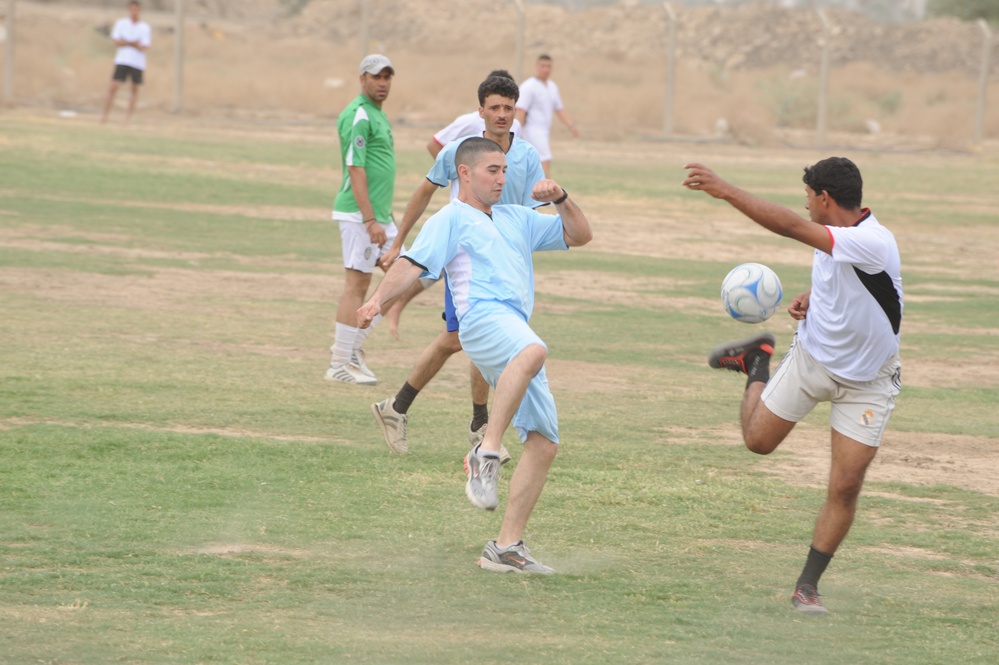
[761,335,902,448]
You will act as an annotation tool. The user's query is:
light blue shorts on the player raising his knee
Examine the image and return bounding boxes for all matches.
[458,303,558,443]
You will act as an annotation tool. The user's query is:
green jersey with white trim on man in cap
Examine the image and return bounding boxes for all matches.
[333,94,395,224]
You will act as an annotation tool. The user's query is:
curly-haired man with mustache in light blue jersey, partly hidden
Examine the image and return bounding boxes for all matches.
[371,76,545,463]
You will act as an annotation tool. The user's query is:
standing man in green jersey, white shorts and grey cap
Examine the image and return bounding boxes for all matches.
[326,53,410,385]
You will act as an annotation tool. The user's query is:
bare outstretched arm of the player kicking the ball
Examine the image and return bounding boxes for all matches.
[681,163,832,254]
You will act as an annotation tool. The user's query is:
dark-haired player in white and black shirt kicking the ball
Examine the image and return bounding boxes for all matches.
[683,157,902,614]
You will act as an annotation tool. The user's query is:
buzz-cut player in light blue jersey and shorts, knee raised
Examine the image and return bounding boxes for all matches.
[357,138,593,574]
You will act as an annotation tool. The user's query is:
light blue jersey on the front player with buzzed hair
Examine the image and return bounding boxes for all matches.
[404,198,568,321]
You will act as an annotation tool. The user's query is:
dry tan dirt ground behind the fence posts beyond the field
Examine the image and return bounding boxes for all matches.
[0,0,999,149]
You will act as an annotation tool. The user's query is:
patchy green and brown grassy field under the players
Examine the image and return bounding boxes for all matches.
[0,114,999,665]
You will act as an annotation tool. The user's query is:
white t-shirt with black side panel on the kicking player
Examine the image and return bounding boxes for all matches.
[798,210,902,381]
